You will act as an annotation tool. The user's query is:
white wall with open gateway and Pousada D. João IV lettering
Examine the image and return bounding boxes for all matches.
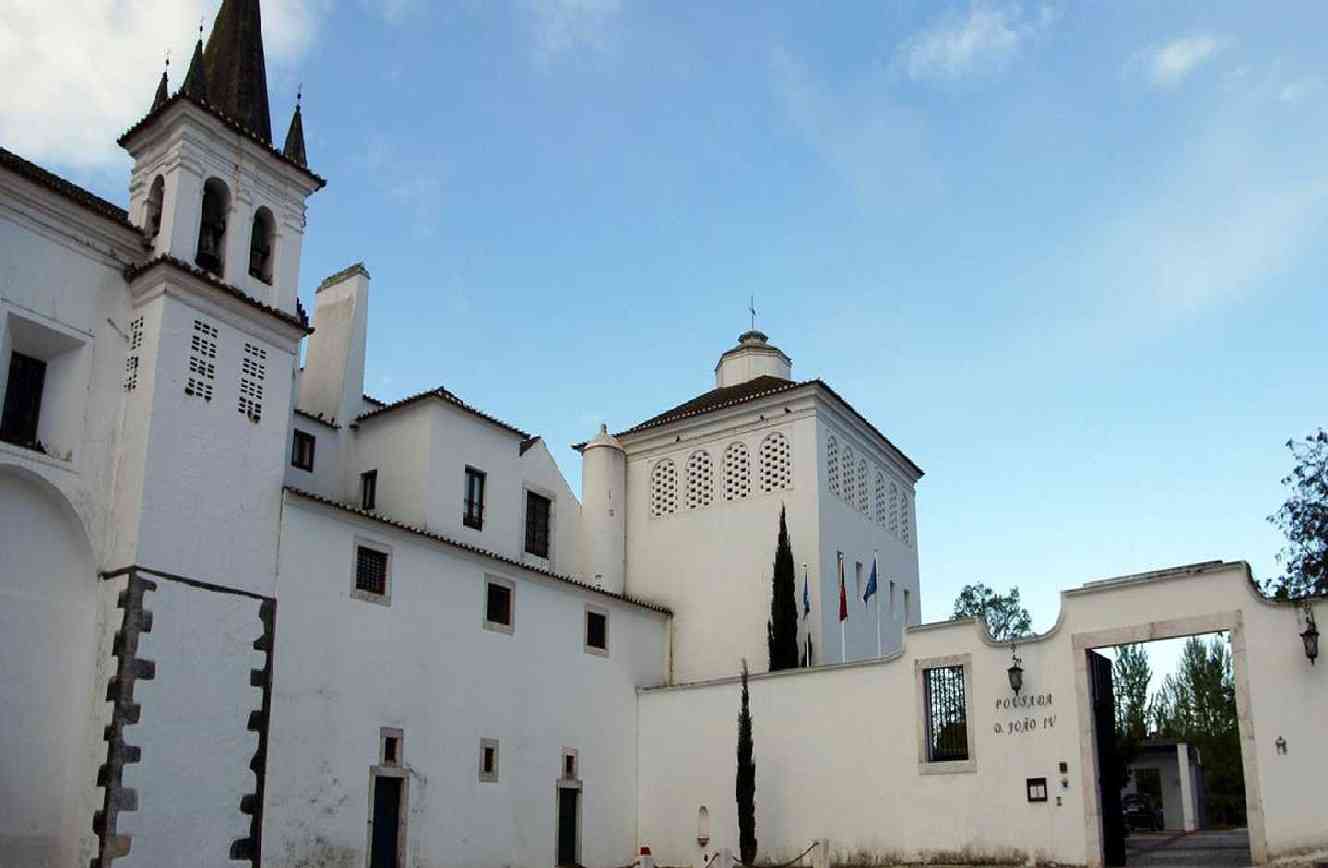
[639,563,1328,865]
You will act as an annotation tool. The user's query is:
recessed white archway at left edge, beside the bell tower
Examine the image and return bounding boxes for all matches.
[0,465,97,865]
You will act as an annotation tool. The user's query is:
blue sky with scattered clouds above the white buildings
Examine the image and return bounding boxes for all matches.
[10,0,1328,639]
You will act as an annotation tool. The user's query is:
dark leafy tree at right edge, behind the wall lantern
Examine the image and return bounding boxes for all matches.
[1267,429,1328,600]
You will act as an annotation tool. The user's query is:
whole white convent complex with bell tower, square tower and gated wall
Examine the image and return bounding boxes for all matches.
[0,0,1328,868]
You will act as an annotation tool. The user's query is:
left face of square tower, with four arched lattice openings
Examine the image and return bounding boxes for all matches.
[623,396,825,681]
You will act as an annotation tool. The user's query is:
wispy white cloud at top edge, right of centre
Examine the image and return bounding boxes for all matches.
[896,3,1056,80]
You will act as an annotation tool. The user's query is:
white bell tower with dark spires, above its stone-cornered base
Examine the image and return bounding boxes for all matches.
[114,0,325,593]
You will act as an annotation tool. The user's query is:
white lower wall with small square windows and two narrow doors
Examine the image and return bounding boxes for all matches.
[264,495,668,867]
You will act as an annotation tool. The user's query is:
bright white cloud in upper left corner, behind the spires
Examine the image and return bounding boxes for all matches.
[0,0,327,169]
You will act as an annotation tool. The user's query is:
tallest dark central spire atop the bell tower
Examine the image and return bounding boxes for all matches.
[203,0,272,143]
